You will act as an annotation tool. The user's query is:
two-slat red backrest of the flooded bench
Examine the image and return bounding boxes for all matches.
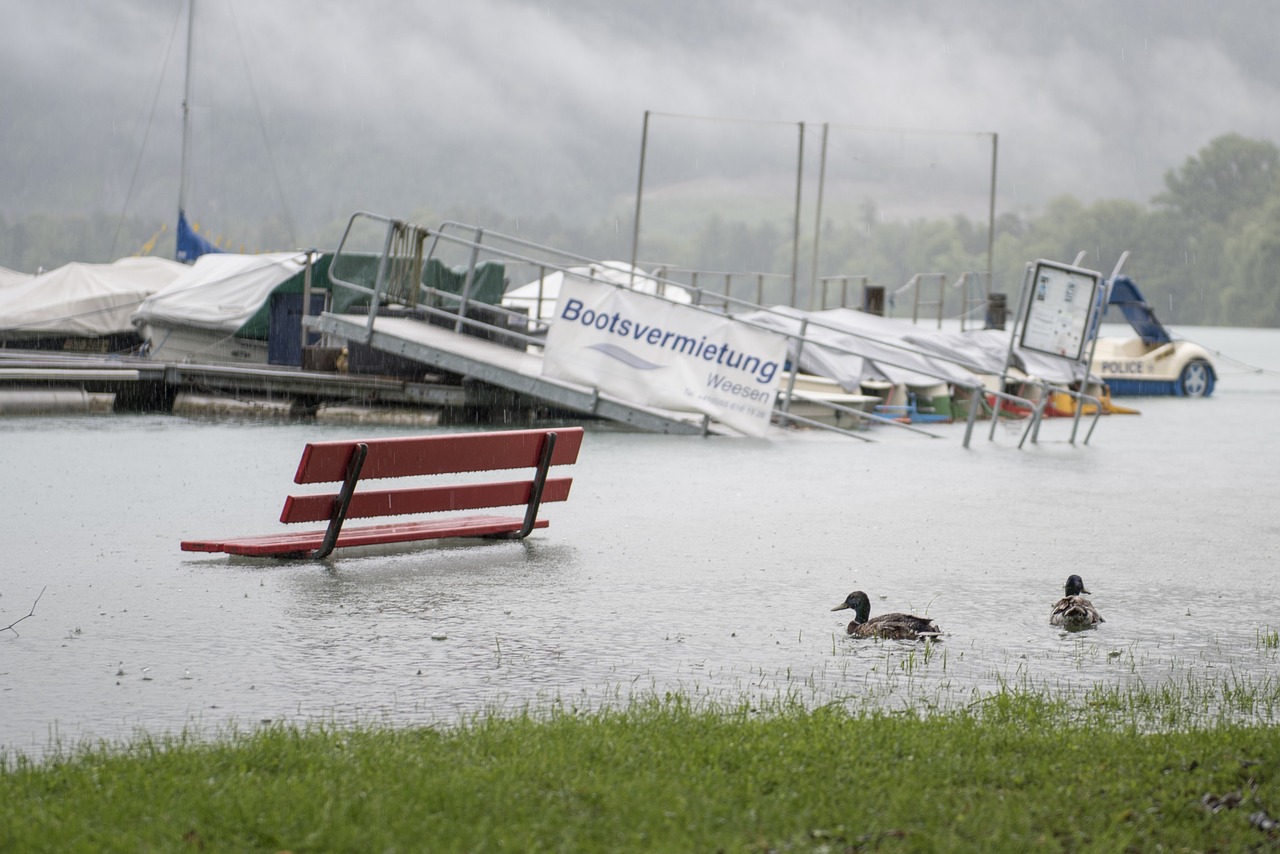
[280,428,582,522]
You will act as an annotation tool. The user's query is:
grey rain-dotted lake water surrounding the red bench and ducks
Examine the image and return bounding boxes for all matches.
[0,328,1280,754]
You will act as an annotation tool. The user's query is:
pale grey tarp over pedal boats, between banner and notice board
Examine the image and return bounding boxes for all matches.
[739,306,1084,393]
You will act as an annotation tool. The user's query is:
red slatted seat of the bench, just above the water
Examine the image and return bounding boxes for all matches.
[182,516,547,557]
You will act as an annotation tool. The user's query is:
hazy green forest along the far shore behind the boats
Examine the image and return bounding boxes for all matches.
[0,134,1280,326]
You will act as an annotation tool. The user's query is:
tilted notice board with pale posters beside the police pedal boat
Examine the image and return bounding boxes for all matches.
[1018,260,1102,362]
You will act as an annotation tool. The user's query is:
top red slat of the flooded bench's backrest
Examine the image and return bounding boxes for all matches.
[293,428,582,484]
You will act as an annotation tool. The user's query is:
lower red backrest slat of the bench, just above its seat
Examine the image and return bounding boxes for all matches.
[280,478,573,524]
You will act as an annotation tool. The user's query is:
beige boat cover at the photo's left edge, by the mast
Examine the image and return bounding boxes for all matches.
[0,257,187,338]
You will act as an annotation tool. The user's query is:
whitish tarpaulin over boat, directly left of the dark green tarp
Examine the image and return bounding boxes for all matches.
[133,252,307,334]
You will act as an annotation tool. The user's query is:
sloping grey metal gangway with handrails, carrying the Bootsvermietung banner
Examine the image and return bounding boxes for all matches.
[303,211,1101,447]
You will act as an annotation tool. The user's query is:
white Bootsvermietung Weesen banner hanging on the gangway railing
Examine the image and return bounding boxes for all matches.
[543,277,787,435]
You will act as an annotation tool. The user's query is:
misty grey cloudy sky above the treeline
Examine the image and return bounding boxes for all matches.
[0,0,1280,242]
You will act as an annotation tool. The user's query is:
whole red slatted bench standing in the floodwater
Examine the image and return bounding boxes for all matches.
[182,428,582,558]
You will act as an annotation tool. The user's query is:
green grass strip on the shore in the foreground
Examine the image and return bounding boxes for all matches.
[0,686,1280,851]
